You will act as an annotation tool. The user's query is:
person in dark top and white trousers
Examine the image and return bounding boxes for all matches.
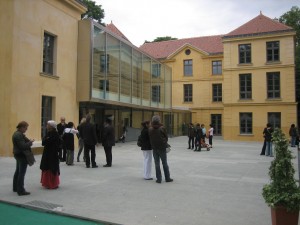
[140,120,153,180]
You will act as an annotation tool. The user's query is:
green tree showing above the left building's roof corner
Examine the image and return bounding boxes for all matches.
[81,0,104,25]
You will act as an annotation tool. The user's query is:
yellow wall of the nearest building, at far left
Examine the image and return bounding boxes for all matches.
[0,0,86,156]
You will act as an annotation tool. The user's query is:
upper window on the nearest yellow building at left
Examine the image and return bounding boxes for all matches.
[43,33,54,75]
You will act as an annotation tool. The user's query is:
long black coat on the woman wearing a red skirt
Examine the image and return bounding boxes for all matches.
[40,130,61,174]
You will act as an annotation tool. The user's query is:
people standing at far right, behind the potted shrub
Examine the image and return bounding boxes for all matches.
[260,123,299,157]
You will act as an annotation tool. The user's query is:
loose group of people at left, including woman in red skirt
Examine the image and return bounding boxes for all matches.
[12,114,115,196]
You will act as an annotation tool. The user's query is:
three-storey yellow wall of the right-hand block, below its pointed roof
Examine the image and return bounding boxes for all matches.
[223,21,297,141]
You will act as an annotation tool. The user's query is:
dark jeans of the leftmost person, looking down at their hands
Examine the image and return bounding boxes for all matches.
[13,156,28,193]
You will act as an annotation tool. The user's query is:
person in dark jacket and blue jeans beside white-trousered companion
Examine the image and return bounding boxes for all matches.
[149,115,173,183]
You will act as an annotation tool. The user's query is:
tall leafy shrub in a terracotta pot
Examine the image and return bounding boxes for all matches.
[262,128,300,225]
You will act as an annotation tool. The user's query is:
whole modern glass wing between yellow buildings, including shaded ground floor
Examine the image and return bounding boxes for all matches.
[77,20,191,138]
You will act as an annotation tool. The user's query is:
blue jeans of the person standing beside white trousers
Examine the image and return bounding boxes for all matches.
[153,149,170,181]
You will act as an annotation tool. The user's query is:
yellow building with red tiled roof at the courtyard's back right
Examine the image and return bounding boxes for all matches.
[140,14,297,141]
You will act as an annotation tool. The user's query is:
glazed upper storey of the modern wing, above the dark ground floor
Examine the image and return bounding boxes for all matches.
[92,23,172,110]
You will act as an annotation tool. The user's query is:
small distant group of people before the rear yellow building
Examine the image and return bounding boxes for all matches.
[187,123,214,152]
